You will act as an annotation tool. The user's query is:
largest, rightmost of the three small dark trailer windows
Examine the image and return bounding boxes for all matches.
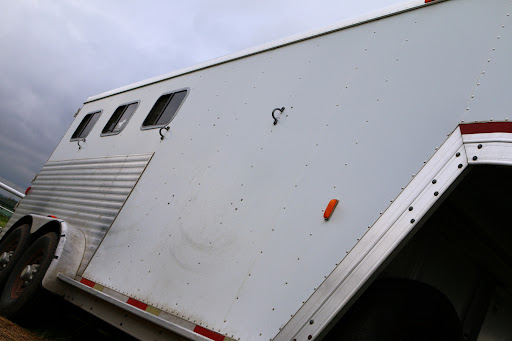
[142,90,188,129]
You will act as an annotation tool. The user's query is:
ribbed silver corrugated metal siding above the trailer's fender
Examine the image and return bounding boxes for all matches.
[8,153,153,274]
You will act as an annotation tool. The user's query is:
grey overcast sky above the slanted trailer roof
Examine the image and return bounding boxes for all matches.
[0,0,402,199]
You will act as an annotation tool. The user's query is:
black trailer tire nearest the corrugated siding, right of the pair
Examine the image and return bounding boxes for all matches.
[0,232,59,318]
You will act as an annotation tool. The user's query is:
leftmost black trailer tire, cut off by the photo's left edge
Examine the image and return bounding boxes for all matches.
[0,224,30,291]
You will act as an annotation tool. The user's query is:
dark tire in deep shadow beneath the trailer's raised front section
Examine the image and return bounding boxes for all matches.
[324,279,462,341]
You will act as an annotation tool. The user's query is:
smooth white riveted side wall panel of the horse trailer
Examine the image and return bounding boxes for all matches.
[8,0,512,340]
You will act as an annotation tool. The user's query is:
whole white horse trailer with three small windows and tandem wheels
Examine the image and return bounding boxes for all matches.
[0,0,512,341]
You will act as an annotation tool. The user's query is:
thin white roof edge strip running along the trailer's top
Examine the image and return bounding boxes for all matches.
[84,0,447,104]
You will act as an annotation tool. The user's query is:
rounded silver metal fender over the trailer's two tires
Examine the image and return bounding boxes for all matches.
[20,214,85,295]
